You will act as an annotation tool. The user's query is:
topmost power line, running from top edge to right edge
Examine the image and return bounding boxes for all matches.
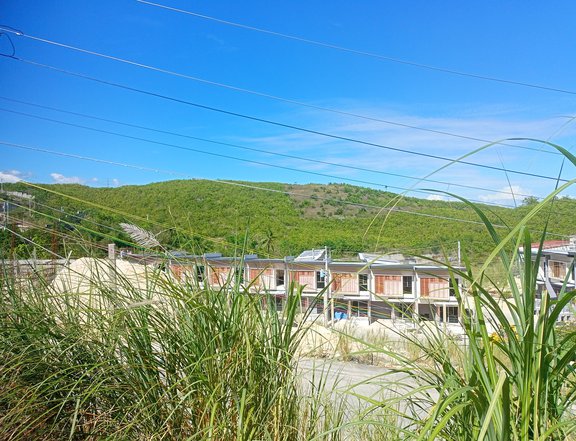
[137,0,576,95]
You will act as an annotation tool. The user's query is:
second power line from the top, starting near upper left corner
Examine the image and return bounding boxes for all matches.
[0,27,560,155]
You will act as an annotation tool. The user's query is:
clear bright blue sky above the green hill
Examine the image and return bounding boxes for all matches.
[0,0,576,205]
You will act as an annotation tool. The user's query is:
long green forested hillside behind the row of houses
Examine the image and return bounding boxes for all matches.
[1,180,576,261]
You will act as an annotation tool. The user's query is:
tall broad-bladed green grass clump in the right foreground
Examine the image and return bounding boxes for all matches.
[356,205,576,434]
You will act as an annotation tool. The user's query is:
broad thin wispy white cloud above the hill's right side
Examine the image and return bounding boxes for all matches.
[223,103,576,201]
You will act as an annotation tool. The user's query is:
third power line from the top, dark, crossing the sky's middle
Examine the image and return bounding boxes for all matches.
[7,57,568,182]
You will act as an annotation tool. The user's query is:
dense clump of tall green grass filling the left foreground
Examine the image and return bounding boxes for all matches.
[0,258,338,440]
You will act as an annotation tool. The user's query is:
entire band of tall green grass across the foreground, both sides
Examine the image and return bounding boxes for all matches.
[0,142,576,441]
